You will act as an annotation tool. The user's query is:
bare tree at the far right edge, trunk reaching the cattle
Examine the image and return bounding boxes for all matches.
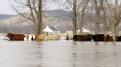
[107,0,121,40]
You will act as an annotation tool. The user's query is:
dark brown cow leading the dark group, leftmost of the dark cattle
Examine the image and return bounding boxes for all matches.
[73,34,92,41]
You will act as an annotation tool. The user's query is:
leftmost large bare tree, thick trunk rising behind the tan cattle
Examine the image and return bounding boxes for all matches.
[12,0,42,34]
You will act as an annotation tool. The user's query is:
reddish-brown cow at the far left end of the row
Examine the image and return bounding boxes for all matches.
[7,33,25,41]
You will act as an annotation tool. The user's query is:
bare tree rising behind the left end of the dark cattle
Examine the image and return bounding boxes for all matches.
[57,0,89,35]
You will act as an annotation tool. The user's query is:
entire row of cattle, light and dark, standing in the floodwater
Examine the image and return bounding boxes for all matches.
[7,33,121,41]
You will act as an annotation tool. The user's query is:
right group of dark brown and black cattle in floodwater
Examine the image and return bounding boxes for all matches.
[73,34,121,41]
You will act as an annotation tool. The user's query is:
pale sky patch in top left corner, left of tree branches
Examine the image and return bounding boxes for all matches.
[0,0,15,14]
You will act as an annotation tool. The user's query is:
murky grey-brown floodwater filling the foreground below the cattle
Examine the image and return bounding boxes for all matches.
[0,40,121,67]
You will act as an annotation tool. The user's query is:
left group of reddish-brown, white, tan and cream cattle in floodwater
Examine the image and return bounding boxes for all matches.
[7,33,66,41]
